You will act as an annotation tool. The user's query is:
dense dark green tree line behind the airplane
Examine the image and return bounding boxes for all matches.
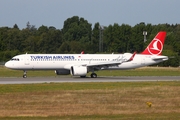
[0,16,180,66]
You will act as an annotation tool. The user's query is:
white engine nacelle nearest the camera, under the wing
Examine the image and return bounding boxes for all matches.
[71,66,87,76]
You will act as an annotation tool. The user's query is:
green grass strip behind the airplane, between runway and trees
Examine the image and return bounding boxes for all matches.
[0,66,180,77]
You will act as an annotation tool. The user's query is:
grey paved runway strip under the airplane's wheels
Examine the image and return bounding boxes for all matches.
[0,76,180,84]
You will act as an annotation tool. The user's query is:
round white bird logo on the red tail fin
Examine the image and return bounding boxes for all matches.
[148,38,163,55]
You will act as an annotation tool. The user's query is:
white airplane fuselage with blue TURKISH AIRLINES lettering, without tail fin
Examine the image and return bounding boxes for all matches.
[5,54,168,70]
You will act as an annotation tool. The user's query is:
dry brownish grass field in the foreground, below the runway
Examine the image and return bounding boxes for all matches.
[0,81,180,120]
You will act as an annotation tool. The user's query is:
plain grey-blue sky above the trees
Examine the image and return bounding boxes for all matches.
[0,0,180,29]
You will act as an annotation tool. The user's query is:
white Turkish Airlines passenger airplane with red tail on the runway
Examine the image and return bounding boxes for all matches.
[5,31,168,78]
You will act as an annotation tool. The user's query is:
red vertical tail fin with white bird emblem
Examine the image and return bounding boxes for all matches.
[141,31,166,55]
